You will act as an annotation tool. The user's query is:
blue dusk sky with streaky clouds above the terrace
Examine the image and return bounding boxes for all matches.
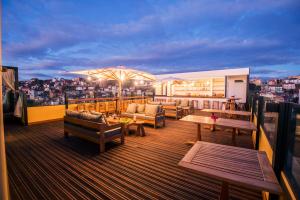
[2,0,300,79]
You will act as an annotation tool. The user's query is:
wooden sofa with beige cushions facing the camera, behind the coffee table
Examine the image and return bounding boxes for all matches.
[121,103,165,128]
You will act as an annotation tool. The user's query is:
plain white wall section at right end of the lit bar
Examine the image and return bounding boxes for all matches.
[226,76,248,103]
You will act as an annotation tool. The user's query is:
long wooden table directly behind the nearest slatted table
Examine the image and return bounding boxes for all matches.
[180,115,257,145]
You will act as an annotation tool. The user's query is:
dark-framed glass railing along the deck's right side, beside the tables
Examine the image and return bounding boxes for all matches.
[249,96,300,199]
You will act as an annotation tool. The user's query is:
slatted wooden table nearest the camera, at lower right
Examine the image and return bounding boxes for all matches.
[178,141,282,199]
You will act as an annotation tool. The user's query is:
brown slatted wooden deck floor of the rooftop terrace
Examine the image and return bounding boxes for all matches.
[6,120,261,200]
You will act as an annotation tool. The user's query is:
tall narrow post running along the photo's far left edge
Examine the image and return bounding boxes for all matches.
[0,2,9,200]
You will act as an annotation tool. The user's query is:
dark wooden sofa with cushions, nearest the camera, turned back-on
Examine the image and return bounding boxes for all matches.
[64,111,124,153]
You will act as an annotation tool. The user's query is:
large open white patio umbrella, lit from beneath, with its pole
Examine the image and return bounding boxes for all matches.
[71,66,155,110]
